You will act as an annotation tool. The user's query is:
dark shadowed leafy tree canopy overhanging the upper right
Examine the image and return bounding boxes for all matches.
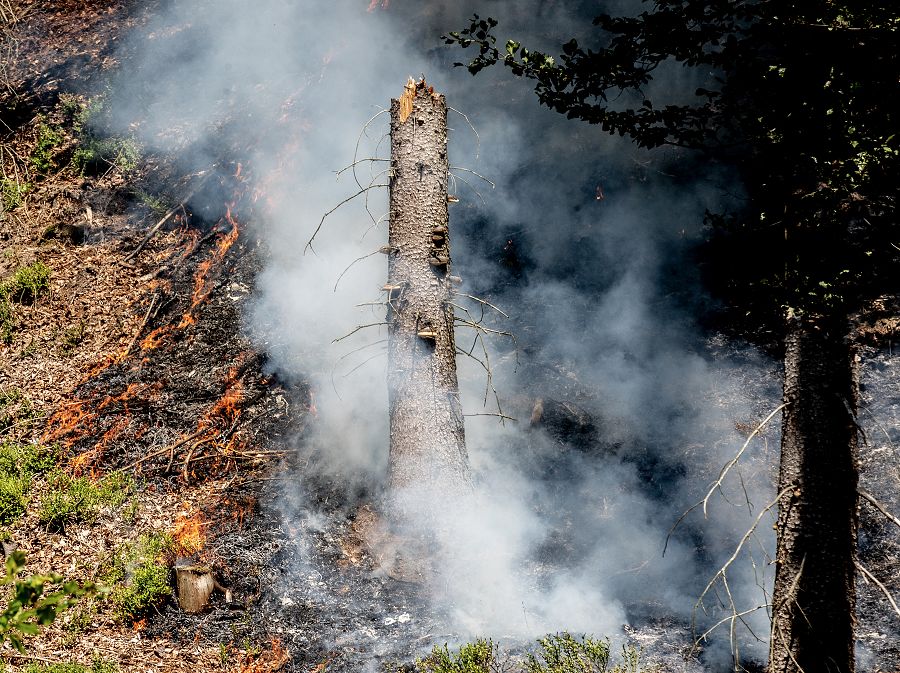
[446,0,900,326]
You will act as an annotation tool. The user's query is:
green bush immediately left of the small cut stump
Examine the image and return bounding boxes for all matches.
[103,534,173,620]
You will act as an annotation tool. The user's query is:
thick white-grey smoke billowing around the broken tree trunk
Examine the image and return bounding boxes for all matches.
[105,0,776,668]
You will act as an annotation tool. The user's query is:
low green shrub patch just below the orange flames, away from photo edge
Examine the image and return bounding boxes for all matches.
[38,470,131,531]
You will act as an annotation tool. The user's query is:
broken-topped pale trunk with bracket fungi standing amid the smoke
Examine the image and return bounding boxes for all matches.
[385,80,469,510]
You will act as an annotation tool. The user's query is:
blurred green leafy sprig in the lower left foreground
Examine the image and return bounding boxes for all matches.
[0,550,96,652]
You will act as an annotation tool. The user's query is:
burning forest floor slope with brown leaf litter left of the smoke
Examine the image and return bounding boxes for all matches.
[0,0,900,673]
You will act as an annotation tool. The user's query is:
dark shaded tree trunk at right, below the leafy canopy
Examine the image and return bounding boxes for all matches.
[769,319,859,673]
